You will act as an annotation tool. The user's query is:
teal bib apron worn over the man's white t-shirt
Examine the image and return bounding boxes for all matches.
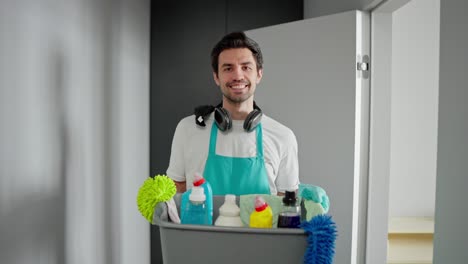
[203,122,270,195]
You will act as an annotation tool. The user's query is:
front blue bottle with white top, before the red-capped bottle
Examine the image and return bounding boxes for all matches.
[181,186,211,225]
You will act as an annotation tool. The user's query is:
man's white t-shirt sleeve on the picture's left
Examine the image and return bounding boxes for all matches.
[166,120,187,182]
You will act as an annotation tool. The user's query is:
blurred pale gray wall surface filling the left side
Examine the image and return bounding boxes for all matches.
[0,0,150,264]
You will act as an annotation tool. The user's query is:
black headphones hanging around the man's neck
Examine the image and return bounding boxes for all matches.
[194,102,263,132]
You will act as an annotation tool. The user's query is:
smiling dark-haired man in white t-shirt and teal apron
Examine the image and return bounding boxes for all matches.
[167,32,299,195]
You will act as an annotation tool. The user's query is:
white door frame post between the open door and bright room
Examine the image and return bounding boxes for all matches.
[365,0,411,263]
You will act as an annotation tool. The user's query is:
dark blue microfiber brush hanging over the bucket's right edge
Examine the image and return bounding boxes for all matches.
[301,215,337,264]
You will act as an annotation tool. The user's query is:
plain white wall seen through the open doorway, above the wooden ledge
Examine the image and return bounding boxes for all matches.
[389,0,440,217]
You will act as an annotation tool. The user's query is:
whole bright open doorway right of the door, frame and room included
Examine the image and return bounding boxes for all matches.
[366,0,440,263]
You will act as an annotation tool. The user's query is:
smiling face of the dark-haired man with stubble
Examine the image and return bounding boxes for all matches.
[213,48,263,103]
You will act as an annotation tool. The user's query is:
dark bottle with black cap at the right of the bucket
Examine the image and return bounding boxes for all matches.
[278,191,301,228]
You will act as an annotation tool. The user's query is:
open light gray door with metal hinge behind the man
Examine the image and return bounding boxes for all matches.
[246,11,370,263]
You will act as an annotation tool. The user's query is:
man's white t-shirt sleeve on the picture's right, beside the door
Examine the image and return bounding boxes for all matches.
[275,131,299,192]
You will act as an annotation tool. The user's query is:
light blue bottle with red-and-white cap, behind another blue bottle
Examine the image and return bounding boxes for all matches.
[180,172,213,225]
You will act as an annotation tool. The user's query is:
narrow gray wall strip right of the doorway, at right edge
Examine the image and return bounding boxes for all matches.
[434,0,468,264]
